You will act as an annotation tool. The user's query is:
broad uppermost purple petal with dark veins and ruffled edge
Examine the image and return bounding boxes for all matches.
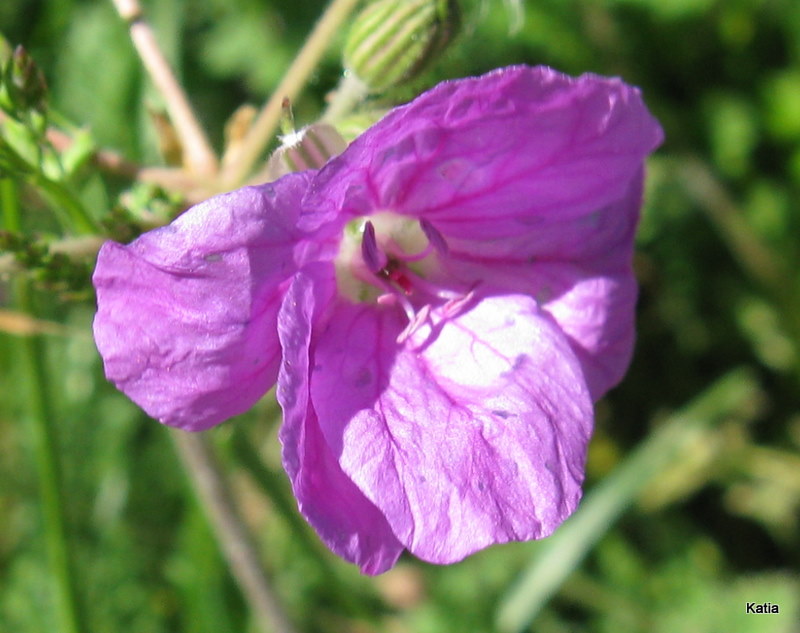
[309,66,662,246]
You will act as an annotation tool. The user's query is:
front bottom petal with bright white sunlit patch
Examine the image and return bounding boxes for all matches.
[311,295,592,563]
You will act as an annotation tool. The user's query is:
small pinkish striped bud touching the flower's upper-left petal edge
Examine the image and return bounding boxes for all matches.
[267,123,347,180]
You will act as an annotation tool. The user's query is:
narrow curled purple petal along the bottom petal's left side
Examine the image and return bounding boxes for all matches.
[277,266,403,574]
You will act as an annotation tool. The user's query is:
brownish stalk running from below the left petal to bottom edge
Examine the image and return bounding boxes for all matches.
[172,430,293,633]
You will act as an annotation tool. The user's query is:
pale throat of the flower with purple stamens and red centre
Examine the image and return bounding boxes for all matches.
[335,211,473,343]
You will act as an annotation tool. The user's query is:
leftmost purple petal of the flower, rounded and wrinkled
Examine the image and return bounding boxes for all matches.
[93,174,321,431]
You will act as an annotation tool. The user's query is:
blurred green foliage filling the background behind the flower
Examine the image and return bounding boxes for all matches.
[0,0,800,633]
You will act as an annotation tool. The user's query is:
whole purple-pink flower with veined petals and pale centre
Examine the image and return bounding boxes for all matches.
[94,66,662,574]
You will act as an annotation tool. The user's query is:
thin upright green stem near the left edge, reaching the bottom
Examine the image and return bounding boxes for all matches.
[2,180,88,633]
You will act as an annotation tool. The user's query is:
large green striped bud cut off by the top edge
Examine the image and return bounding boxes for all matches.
[344,0,459,92]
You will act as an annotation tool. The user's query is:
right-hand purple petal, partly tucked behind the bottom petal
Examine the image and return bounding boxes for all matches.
[439,173,642,400]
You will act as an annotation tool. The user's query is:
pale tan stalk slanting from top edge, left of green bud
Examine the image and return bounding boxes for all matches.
[220,0,359,190]
